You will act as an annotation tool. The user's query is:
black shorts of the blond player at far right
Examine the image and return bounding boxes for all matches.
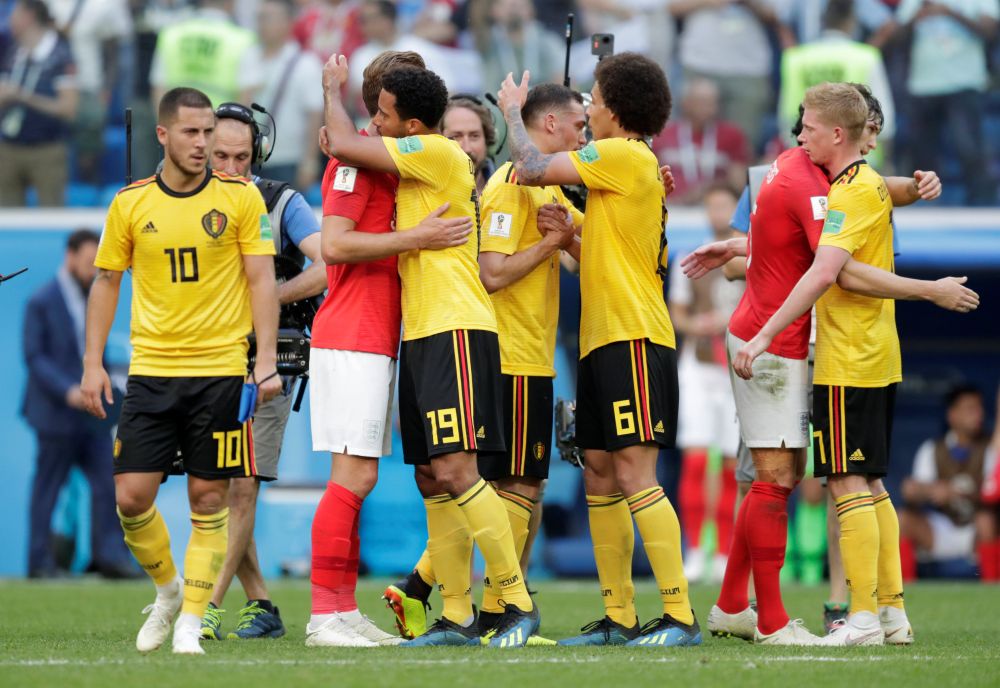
[813,384,896,478]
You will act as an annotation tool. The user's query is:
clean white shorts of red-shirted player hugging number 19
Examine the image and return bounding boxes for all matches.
[309,348,396,458]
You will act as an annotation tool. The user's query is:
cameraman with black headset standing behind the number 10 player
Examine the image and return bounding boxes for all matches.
[202,103,326,640]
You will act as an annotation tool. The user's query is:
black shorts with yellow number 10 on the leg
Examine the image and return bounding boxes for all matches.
[114,375,257,480]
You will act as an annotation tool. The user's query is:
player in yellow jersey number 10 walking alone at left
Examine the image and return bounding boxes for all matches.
[80,88,281,654]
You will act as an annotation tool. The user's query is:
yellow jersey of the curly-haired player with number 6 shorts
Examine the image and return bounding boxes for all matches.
[569,138,676,358]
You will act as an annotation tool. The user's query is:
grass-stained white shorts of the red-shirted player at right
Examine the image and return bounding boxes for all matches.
[726,332,810,449]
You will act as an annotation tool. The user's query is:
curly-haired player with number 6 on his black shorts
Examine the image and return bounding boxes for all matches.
[500,53,701,647]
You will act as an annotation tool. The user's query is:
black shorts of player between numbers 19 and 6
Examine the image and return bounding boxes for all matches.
[478,375,554,480]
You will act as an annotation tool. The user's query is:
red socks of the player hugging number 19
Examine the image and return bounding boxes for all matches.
[310,481,362,614]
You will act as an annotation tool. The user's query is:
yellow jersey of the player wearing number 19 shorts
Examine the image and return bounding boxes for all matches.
[382,134,497,341]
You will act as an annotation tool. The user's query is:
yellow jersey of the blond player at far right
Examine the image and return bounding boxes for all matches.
[813,160,903,387]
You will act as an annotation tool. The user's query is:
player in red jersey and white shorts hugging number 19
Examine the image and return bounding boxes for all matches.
[306,51,472,647]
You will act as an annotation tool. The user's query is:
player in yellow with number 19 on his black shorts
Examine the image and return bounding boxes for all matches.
[323,55,539,647]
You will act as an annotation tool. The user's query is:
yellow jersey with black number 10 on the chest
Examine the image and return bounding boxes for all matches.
[94,170,280,377]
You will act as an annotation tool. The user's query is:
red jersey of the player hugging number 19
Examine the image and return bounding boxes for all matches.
[312,139,401,358]
